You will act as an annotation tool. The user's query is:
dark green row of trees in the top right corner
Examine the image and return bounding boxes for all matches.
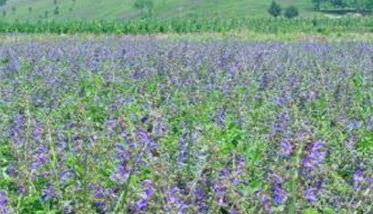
[312,0,373,13]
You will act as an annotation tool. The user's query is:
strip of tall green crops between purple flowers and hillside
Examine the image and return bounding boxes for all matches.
[0,17,373,34]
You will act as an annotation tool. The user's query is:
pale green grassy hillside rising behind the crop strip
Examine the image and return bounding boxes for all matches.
[0,0,313,21]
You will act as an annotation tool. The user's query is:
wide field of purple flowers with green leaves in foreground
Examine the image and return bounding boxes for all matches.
[0,37,373,214]
